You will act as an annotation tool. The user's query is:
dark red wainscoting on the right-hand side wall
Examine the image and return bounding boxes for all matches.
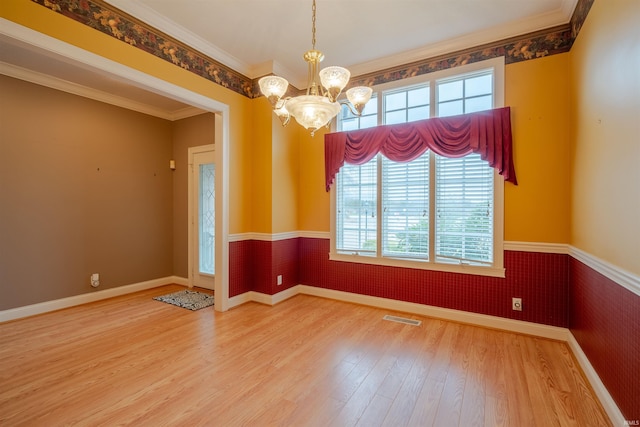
[568,258,640,421]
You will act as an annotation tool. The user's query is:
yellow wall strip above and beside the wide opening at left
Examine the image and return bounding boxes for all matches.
[0,0,254,233]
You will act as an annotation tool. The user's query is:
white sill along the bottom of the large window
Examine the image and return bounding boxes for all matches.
[329,252,505,278]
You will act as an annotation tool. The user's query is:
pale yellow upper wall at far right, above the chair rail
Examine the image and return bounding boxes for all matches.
[570,0,640,274]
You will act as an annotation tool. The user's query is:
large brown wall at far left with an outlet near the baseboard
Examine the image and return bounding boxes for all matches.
[0,76,175,310]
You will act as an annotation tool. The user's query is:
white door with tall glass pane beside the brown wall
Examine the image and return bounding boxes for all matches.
[189,146,216,289]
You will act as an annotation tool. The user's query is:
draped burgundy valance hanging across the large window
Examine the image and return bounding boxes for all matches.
[324,107,518,191]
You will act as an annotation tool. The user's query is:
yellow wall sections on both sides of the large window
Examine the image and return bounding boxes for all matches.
[298,54,570,243]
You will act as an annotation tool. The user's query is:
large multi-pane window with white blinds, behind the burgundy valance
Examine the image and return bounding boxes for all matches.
[331,58,504,277]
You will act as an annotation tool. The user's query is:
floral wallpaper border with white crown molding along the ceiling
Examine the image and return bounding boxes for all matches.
[32,0,593,98]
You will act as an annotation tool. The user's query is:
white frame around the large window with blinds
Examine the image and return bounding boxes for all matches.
[329,57,505,277]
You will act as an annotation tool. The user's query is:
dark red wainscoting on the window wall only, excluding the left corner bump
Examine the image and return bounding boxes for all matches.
[299,238,568,327]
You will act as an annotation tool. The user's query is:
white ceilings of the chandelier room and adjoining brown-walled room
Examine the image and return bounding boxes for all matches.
[0,0,577,120]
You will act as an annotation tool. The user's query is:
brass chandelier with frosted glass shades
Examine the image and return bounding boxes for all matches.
[258,0,372,136]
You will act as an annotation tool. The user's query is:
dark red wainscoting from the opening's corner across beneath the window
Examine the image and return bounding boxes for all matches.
[229,238,568,327]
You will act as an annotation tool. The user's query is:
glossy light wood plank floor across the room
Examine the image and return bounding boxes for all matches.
[0,286,611,427]
